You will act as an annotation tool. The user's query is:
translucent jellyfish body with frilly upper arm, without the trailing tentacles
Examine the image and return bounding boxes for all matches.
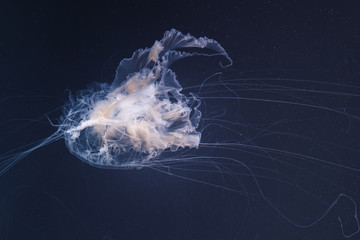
[61,29,231,168]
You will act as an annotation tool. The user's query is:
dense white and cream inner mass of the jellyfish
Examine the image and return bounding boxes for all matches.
[67,71,200,160]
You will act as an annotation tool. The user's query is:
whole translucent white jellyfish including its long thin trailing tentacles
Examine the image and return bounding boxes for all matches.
[0,29,360,238]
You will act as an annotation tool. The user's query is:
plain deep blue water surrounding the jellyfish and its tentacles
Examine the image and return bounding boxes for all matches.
[0,1,360,240]
